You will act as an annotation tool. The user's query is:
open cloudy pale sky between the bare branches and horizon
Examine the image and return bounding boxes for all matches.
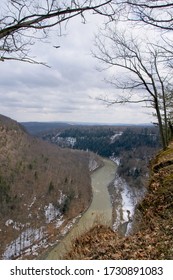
[0,10,152,124]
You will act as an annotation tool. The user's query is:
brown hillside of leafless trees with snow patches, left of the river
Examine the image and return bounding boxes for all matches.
[0,115,91,259]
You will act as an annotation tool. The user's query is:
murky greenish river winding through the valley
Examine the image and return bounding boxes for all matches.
[46,159,117,260]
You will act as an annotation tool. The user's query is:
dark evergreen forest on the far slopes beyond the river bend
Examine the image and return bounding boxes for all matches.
[29,125,161,187]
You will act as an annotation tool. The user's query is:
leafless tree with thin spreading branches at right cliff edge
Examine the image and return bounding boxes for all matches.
[94,29,173,149]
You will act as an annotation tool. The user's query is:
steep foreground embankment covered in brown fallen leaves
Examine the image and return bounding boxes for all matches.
[65,143,173,260]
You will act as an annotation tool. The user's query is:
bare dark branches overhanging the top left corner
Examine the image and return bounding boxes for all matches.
[0,0,114,63]
